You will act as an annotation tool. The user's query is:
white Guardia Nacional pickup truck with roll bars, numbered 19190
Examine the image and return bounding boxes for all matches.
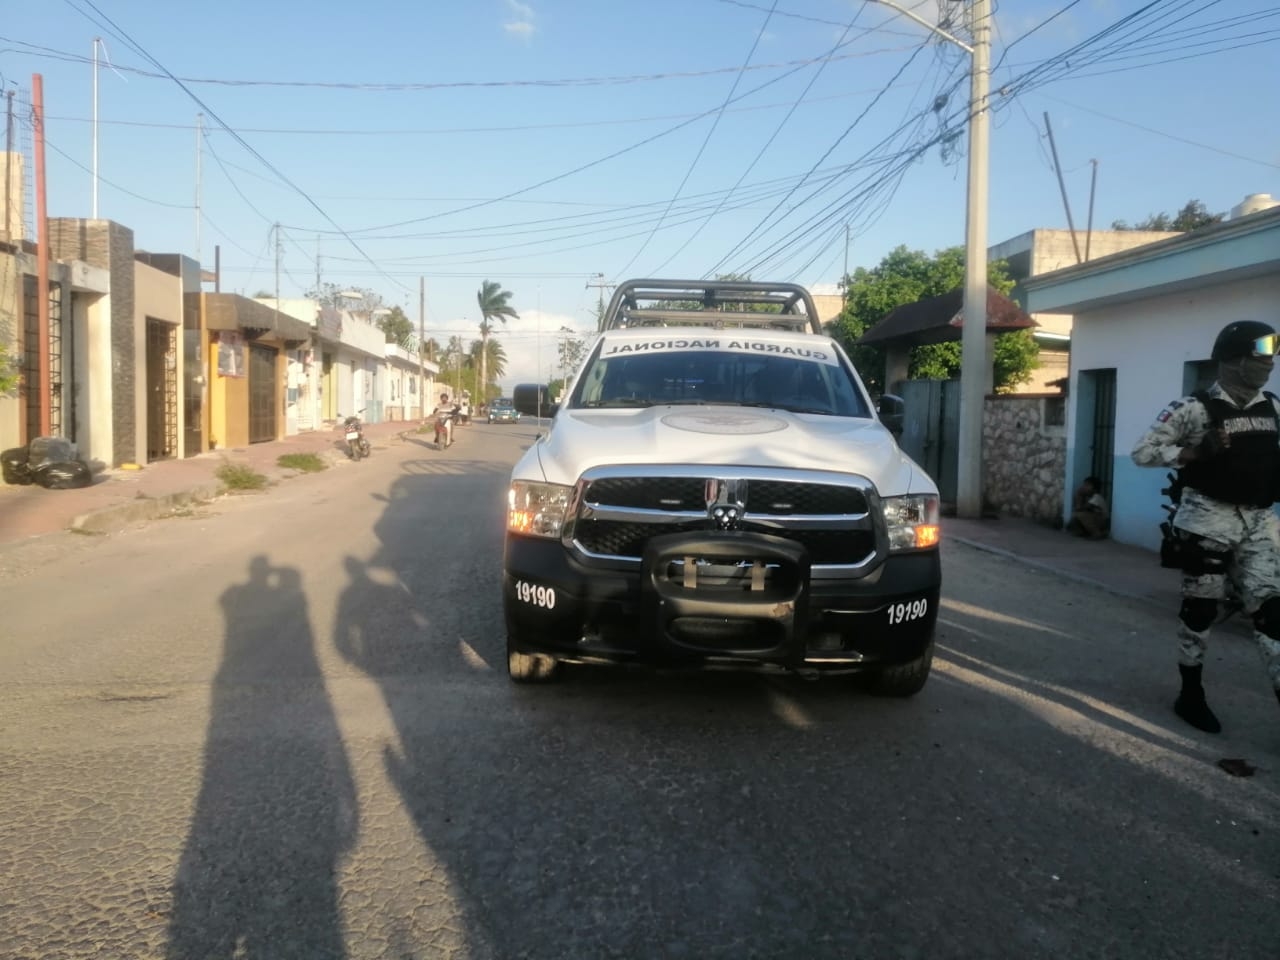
[503,280,942,696]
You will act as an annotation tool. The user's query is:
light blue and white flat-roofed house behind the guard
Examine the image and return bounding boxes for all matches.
[1023,204,1280,549]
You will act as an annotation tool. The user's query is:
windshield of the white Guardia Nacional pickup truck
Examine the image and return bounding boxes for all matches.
[570,349,870,417]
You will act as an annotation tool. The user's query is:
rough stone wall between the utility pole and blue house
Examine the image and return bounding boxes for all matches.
[982,396,1066,526]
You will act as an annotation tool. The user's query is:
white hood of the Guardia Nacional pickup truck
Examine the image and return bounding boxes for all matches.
[512,406,936,497]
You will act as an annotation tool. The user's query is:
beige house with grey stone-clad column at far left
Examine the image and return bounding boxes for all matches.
[0,218,200,466]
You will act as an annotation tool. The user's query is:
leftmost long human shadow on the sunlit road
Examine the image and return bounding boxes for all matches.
[168,556,357,960]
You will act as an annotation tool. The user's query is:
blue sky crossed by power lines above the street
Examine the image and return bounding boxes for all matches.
[0,0,1280,385]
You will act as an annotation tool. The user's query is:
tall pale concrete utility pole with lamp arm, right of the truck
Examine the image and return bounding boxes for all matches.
[873,0,991,518]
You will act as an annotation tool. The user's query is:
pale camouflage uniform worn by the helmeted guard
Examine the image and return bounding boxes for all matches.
[1132,384,1280,696]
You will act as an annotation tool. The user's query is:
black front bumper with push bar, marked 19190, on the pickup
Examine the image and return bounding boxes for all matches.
[503,532,942,672]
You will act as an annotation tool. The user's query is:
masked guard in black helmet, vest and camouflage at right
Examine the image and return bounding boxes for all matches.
[1132,320,1280,733]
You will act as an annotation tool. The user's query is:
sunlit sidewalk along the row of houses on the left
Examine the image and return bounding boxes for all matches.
[0,420,430,544]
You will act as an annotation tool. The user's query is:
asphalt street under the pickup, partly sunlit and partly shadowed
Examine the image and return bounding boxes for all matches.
[0,424,1280,960]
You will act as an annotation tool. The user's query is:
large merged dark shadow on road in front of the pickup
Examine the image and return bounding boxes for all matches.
[337,453,1277,960]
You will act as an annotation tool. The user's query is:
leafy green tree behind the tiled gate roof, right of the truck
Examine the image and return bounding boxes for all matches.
[827,246,1039,393]
